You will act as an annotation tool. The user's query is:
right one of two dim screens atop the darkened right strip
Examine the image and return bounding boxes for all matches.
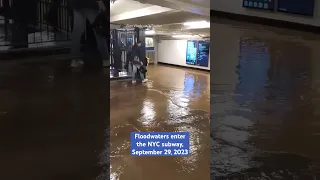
[278,0,315,16]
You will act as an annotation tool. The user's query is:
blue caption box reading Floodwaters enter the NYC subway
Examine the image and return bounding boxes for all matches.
[130,132,190,156]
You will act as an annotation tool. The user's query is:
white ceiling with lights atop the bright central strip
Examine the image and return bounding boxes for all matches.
[110,0,210,36]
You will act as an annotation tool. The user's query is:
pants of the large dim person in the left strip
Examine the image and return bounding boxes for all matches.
[71,9,109,60]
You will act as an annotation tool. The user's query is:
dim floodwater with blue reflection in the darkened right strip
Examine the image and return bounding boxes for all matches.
[210,19,320,180]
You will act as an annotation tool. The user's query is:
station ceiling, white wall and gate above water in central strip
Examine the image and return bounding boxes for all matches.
[110,0,210,79]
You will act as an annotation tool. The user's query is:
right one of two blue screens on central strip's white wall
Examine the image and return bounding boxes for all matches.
[197,41,210,67]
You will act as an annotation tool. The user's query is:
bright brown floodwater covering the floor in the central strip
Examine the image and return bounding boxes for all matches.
[110,66,210,180]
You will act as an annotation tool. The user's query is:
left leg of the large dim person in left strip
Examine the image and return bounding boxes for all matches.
[71,10,86,67]
